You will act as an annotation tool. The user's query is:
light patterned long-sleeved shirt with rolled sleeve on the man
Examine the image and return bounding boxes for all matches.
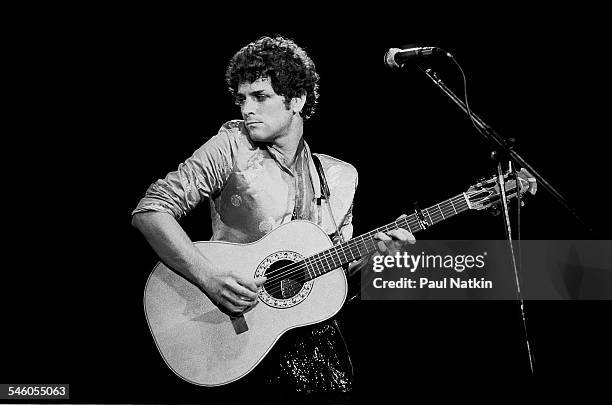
[133,120,358,243]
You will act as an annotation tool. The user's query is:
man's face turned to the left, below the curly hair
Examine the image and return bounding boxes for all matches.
[236,78,293,142]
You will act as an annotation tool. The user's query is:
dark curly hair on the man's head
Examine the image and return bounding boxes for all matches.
[225,36,319,120]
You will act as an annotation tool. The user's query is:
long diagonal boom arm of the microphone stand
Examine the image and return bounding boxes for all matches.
[417,64,593,233]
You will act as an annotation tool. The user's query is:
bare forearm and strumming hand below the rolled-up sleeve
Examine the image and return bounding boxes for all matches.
[132,211,265,315]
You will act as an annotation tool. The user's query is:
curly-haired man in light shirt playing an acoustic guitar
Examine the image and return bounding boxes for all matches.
[132,37,414,392]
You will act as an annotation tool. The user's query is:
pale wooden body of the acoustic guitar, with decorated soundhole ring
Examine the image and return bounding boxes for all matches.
[144,221,347,386]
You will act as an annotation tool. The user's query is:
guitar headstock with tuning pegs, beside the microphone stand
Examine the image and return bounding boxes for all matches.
[464,169,538,210]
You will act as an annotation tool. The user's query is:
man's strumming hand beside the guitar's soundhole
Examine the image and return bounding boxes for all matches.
[201,271,266,316]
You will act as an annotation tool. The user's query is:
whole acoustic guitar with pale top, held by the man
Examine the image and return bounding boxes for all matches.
[144,169,536,386]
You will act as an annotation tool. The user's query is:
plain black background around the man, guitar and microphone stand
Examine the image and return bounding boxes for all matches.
[2,9,612,402]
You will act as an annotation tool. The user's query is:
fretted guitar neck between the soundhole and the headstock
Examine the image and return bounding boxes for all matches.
[304,193,469,279]
